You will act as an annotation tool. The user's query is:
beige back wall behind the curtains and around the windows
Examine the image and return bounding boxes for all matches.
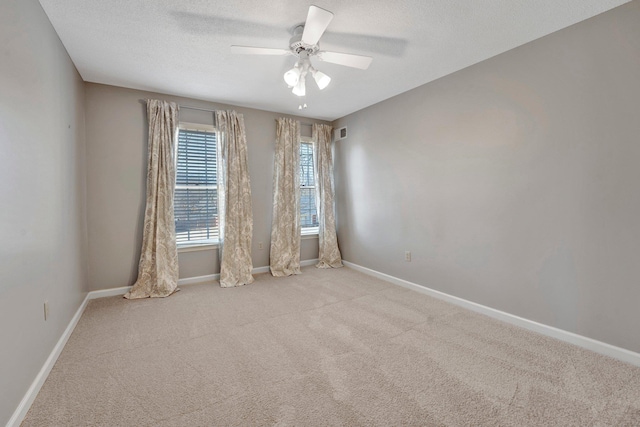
[86,83,324,290]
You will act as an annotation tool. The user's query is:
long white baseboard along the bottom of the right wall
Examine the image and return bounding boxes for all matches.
[342,261,640,366]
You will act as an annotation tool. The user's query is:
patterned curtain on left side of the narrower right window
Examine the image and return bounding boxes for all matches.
[269,118,300,276]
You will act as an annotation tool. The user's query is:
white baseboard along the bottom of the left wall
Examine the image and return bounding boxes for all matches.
[7,294,90,427]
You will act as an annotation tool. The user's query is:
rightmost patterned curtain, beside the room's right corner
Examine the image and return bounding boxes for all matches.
[312,124,342,268]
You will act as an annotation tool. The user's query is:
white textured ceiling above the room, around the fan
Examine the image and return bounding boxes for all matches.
[40,0,629,120]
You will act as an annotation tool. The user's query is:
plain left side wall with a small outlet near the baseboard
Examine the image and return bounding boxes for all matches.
[0,0,87,425]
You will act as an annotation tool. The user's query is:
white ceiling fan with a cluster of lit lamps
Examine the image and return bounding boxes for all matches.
[231,5,373,96]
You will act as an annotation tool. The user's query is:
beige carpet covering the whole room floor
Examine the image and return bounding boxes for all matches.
[23,267,640,426]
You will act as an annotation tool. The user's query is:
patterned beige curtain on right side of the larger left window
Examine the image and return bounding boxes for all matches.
[216,111,253,288]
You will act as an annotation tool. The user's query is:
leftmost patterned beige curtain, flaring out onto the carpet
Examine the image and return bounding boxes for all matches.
[124,99,178,299]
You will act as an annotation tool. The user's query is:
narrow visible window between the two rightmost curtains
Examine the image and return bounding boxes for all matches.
[300,141,318,234]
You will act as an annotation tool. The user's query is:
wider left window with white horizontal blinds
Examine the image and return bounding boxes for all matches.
[173,123,219,246]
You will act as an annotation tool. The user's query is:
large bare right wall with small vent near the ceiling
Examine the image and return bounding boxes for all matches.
[334,1,640,352]
